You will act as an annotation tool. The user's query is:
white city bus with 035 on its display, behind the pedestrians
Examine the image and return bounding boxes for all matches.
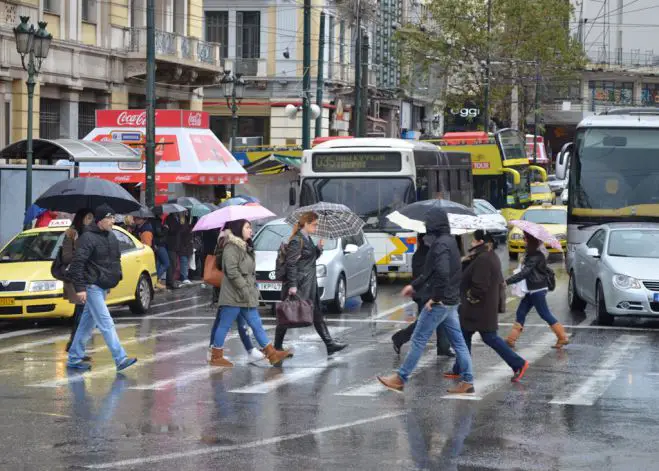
[299,138,473,277]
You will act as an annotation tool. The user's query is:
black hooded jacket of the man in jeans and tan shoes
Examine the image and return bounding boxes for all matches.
[412,209,462,306]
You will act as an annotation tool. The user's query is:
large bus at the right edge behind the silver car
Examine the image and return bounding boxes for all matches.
[556,109,659,273]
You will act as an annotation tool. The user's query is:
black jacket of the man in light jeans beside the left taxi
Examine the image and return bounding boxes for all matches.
[68,224,122,293]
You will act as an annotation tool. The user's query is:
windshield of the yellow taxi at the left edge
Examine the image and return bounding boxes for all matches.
[0,231,64,263]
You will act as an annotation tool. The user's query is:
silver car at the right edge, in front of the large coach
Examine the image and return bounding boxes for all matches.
[568,223,659,325]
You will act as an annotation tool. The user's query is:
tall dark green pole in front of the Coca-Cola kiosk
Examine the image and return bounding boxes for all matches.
[145,0,156,207]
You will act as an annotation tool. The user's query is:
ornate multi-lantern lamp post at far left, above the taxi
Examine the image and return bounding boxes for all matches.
[14,16,53,229]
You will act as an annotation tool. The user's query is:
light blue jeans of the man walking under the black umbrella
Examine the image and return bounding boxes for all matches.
[69,285,127,365]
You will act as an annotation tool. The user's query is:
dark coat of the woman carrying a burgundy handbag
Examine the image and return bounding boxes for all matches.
[282,231,322,307]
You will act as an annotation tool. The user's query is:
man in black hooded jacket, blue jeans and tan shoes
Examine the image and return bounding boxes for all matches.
[378,208,474,394]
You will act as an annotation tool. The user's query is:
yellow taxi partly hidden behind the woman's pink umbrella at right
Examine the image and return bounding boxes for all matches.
[508,203,567,260]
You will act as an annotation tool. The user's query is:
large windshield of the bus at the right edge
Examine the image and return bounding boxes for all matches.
[569,128,659,220]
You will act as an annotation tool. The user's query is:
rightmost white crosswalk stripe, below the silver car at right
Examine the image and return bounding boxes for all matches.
[549,334,650,406]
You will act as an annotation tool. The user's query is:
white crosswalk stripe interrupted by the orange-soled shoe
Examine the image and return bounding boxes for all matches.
[441,333,556,401]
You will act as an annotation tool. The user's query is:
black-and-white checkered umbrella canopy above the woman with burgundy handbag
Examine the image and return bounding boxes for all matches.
[286,203,364,239]
